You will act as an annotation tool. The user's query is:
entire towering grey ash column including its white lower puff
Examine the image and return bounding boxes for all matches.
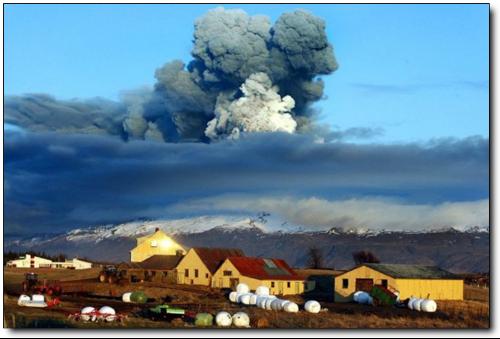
[6,8,337,142]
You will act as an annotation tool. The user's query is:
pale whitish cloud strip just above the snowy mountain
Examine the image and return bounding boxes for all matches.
[173,195,489,231]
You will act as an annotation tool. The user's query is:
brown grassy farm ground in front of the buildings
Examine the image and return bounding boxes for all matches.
[4,268,490,328]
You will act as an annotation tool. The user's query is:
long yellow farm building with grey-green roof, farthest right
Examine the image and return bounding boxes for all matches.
[334,264,464,302]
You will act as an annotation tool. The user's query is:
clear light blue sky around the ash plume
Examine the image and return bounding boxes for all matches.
[5,5,489,143]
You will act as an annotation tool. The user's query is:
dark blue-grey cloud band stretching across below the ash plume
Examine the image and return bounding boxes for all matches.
[4,132,489,232]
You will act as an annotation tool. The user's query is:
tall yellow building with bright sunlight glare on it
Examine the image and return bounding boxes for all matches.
[130,228,186,262]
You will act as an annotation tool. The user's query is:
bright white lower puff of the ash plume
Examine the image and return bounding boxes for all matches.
[205,72,297,140]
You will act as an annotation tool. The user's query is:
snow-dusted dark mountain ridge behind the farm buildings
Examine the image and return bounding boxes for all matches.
[4,217,489,273]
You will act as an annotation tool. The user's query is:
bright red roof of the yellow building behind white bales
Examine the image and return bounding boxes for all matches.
[227,257,304,280]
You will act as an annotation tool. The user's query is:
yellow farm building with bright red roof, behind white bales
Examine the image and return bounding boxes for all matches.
[212,257,314,295]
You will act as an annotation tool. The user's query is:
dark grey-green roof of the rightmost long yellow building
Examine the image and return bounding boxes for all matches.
[363,263,461,279]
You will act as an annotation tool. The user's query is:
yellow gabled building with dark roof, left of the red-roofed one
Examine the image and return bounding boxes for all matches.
[176,247,244,286]
